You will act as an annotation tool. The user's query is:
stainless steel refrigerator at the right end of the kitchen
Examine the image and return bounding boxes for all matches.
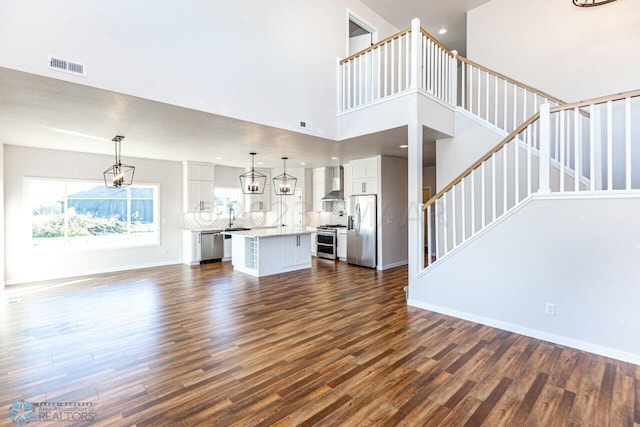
[347,195,378,268]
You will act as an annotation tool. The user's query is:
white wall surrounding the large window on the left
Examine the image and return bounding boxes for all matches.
[4,145,182,283]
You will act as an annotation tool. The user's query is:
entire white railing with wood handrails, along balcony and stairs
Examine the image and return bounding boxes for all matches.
[338,19,640,269]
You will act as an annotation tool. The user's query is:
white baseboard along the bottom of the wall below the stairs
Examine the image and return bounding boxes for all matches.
[407,298,640,365]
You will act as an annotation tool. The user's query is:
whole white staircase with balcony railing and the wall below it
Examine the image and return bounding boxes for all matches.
[338,20,640,363]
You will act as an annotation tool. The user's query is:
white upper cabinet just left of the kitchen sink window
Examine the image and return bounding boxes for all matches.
[183,161,214,212]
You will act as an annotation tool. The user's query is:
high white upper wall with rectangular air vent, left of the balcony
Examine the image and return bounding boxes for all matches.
[0,0,397,137]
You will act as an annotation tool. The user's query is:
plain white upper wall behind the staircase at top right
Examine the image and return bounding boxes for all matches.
[467,0,640,102]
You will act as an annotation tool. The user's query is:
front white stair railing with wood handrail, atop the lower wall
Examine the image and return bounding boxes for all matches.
[423,90,640,267]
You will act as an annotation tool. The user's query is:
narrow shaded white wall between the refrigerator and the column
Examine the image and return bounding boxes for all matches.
[378,156,409,270]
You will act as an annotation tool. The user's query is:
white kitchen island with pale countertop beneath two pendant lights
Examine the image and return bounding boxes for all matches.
[225,228,312,277]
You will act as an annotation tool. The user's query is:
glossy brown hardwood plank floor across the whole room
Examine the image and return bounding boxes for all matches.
[0,259,640,426]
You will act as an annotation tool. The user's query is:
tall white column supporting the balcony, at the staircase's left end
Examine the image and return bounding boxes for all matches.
[407,97,424,288]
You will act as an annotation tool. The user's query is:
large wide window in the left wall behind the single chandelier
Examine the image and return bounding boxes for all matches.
[27,179,159,247]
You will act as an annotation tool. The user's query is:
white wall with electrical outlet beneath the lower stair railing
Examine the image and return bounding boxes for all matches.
[409,193,640,364]
